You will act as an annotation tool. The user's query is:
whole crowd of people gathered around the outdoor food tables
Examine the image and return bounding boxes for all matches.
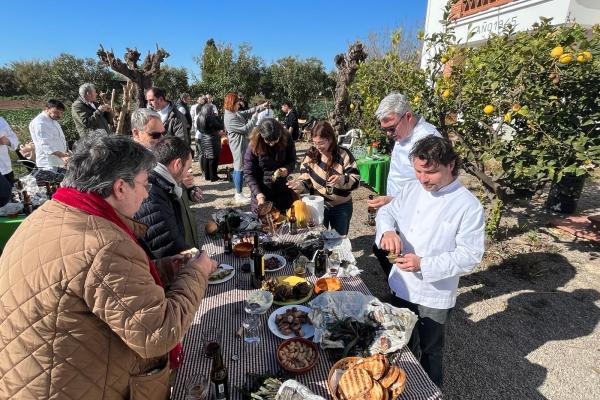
[0,84,484,399]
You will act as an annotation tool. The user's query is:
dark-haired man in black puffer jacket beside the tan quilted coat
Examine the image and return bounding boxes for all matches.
[134,136,193,258]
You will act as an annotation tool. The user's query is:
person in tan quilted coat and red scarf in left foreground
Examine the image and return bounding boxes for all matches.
[0,135,216,400]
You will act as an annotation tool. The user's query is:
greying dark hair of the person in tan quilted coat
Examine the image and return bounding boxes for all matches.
[61,134,156,198]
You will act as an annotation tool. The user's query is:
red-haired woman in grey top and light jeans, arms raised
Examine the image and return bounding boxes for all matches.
[223,92,267,205]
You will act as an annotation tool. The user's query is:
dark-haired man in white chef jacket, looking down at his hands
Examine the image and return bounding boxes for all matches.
[375,135,484,387]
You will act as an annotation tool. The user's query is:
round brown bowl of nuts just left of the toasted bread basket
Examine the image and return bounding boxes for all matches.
[277,337,319,374]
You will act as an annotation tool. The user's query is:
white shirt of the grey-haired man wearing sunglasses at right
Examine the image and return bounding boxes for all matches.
[386,117,442,196]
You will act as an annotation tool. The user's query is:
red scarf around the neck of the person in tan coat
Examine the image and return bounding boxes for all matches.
[52,188,183,368]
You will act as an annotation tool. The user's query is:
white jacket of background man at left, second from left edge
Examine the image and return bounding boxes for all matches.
[29,111,67,169]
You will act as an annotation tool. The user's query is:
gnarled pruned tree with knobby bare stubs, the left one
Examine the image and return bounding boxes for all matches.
[96,44,169,107]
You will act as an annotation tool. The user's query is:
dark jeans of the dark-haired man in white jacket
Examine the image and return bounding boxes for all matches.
[391,293,452,388]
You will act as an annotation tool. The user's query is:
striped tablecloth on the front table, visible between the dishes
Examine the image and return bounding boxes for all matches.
[171,231,442,400]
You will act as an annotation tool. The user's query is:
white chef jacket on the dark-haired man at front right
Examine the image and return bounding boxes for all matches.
[376,179,485,309]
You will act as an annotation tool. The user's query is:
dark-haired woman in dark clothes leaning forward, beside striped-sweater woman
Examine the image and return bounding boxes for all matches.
[244,118,296,212]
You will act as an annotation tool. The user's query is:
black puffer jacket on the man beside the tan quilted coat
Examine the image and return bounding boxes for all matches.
[134,171,190,258]
